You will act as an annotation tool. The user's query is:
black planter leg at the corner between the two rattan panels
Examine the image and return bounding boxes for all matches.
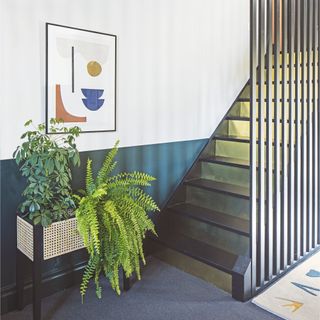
[32,226,43,320]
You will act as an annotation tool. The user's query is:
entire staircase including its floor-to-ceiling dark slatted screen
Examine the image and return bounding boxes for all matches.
[153,0,320,301]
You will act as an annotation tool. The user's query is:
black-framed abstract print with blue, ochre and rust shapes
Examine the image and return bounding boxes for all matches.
[46,23,117,133]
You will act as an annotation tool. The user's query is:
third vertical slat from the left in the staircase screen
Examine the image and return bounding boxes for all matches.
[266,0,274,280]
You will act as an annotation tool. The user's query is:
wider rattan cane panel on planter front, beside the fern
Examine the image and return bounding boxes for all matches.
[43,218,84,260]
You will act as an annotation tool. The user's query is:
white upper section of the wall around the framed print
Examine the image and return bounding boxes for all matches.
[0,0,249,159]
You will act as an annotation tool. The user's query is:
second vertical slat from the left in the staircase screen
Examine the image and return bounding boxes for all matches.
[253,0,266,286]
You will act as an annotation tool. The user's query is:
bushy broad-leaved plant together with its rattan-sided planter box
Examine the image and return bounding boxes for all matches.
[13,119,83,260]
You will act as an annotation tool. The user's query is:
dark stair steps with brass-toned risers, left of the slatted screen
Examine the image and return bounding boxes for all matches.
[154,84,254,300]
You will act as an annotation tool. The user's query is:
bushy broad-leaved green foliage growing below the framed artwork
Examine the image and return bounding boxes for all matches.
[13,119,80,227]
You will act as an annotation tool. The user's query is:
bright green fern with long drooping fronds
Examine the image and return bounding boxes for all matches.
[76,141,159,302]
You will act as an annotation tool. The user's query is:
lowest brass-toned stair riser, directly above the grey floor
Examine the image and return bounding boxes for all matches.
[153,243,232,293]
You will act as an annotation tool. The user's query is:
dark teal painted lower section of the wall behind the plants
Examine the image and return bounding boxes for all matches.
[1,140,206,292]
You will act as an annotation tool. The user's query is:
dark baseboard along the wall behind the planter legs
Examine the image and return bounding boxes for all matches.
[1,261,87,314]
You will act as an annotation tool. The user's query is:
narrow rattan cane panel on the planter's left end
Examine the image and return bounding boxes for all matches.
[17,216,33,261]
